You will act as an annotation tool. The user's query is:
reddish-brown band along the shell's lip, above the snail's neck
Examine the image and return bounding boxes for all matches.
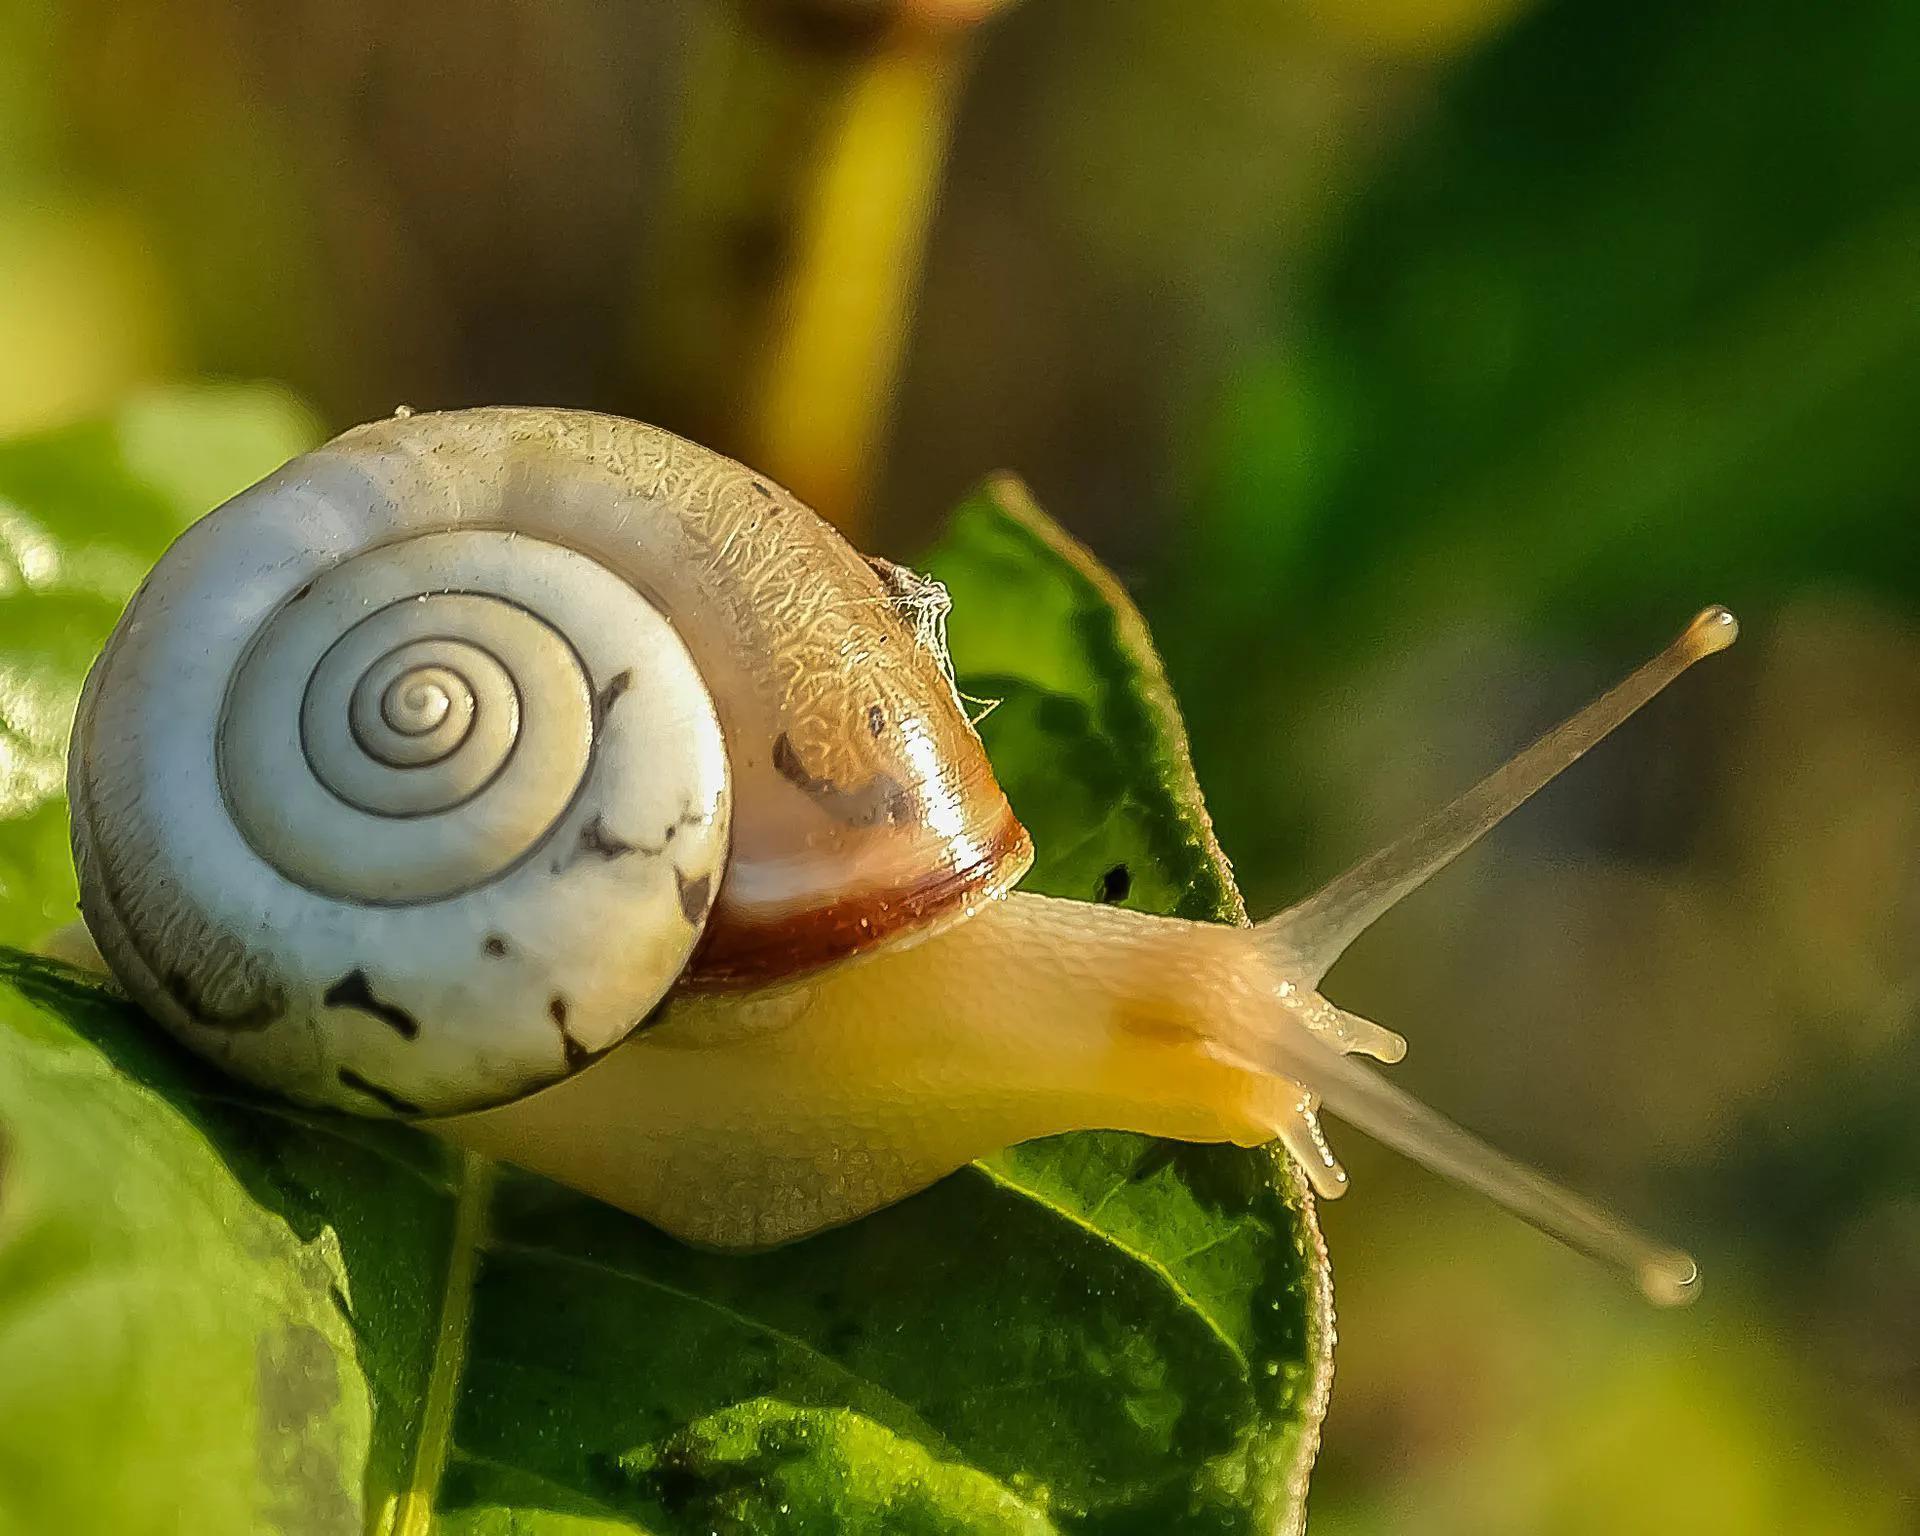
[680,806,1033,991]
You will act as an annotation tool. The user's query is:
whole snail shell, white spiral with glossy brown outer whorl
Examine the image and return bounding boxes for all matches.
[69,409,1031,1114]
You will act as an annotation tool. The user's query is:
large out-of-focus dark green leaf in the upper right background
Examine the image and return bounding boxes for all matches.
[1164,0,1920,898]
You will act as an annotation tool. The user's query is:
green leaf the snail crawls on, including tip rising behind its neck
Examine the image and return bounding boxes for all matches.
[0,464,1331,1536]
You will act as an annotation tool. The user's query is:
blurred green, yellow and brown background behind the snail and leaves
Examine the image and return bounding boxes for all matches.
[0,0,1920,1536]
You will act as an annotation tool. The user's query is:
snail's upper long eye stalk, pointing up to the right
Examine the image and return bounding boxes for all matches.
[1256,607,1740,987]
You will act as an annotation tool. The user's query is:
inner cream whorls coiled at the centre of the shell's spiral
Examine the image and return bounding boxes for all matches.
[219,530,622,902]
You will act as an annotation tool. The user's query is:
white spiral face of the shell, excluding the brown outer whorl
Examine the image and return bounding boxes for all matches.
[69,422,732,1114]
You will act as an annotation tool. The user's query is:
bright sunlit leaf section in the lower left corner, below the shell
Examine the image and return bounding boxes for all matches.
[0,950,378,1536]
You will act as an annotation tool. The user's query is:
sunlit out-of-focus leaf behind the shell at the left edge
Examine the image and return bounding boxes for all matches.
[0,386,317,945]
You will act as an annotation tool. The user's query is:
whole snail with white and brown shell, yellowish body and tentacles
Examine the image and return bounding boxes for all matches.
[69,409,1736,1302]
